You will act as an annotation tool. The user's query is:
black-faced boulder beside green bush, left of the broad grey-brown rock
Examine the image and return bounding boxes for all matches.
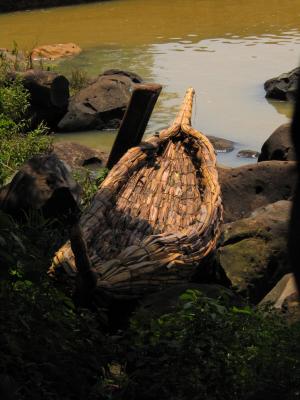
[12,69,69,128]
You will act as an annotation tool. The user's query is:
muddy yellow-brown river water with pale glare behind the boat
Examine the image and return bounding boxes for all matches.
[0,0,300,165]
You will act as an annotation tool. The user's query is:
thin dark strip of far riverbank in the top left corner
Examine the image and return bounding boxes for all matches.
[0,0,109,12]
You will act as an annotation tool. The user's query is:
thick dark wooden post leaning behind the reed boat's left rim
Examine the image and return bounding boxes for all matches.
[107,83,162,169]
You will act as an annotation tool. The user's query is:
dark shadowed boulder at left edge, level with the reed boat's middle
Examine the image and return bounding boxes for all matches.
[0,153,80,217]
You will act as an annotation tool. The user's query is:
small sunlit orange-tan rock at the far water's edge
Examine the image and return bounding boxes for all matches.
[31,43,82,60]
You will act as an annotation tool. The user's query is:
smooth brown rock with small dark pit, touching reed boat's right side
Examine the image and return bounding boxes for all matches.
[218,161,297,222]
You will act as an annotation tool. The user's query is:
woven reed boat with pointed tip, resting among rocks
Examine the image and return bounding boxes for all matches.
[52,88,223,296]
